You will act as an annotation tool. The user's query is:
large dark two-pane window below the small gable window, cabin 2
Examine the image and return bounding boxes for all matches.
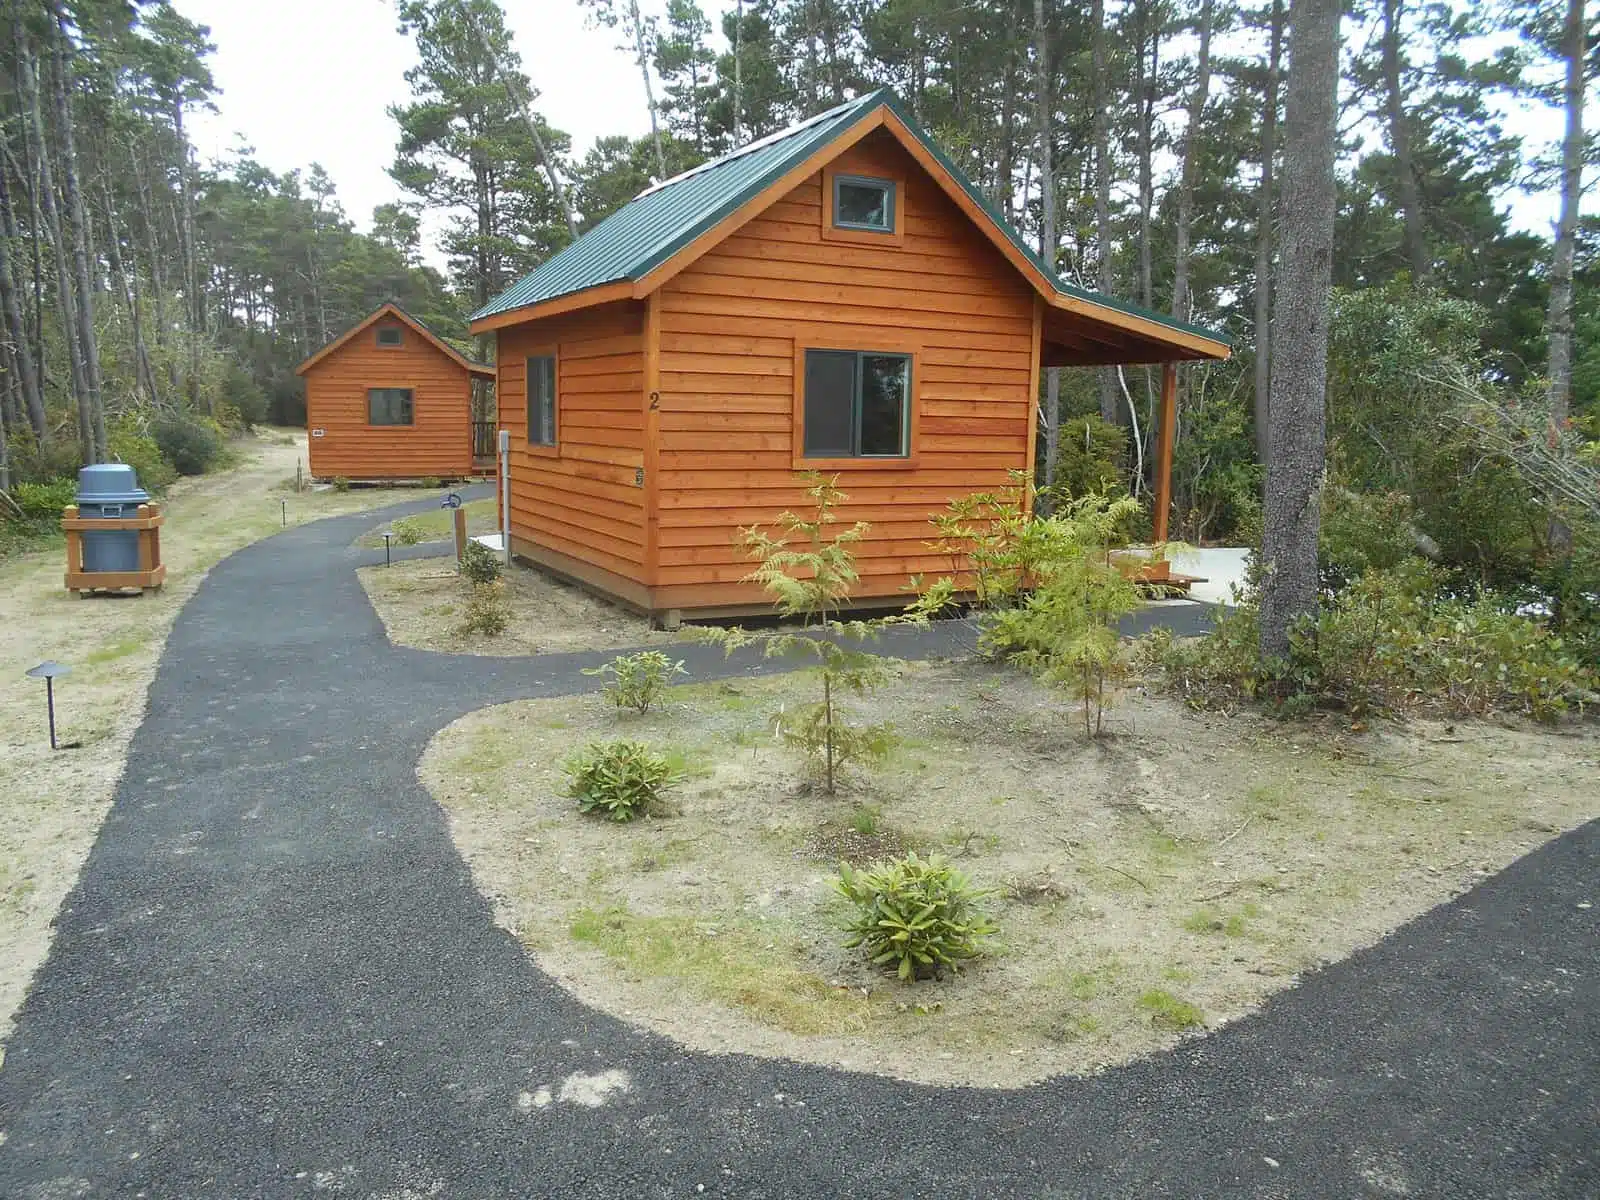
[805,350,910,458]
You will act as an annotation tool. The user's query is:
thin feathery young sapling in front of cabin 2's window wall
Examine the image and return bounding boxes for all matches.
[699,472,920,795]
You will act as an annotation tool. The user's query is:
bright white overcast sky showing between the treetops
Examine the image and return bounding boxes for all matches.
[174,0,1558,262]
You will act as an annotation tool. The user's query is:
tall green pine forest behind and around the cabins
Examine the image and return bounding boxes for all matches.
[0,0,1600,649]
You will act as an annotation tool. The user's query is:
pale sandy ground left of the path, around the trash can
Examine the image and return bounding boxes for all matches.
[0,429,418,1040]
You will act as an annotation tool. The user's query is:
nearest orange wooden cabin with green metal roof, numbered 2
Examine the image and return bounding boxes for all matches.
[472,93,1229,622]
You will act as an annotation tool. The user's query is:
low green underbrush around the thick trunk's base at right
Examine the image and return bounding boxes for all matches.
[1139,560,1600,722]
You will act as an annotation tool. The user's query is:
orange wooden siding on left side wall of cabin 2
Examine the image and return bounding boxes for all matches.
[496,301,650,608]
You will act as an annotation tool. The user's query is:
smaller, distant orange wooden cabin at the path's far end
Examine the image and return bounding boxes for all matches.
[294,304,494,480]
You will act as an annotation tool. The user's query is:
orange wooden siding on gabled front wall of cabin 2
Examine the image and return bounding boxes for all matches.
[652,133,1038,611]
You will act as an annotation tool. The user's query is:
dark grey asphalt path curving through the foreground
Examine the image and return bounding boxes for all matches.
[0,504,1600,1200]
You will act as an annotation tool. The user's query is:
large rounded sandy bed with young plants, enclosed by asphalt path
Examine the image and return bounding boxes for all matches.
[419,664,1600,1086]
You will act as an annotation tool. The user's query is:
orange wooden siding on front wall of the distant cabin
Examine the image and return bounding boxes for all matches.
[306,320,472,480]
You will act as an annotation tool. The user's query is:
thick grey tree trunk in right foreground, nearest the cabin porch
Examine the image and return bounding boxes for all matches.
[1261,0,1342,659]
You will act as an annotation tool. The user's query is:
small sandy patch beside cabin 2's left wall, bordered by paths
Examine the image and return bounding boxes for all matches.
[357,556,686,654]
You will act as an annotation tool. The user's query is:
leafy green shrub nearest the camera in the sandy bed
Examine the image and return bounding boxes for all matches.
[834,853,998,979]
